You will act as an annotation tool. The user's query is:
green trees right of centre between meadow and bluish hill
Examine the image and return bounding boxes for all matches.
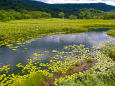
[58,8,115,19]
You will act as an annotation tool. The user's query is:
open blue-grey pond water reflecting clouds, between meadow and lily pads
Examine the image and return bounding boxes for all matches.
[0,28,115,67]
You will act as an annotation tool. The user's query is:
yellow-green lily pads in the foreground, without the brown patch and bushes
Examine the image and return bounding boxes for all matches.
[0,45,115,86]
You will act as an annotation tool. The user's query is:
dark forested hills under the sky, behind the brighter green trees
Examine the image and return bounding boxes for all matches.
[0,0,115,17]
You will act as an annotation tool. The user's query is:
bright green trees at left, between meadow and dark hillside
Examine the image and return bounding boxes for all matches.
[0,9,51,21]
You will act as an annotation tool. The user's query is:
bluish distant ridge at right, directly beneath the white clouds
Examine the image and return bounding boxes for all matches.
[24,0,115,11]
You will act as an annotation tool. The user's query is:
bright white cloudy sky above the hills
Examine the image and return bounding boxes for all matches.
[33,0,115,6]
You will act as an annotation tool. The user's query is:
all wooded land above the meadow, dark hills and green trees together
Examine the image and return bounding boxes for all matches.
[0,0,115,21]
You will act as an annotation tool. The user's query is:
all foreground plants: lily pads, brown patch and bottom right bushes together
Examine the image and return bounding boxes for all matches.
[0,45,115,86]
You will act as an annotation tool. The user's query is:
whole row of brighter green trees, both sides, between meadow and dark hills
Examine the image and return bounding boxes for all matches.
[0,8,115,21]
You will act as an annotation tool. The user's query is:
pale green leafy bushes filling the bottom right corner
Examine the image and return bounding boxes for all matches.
[59,67,115,86]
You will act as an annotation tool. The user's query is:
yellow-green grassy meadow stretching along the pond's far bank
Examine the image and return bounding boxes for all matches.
[0,18,115,46]
